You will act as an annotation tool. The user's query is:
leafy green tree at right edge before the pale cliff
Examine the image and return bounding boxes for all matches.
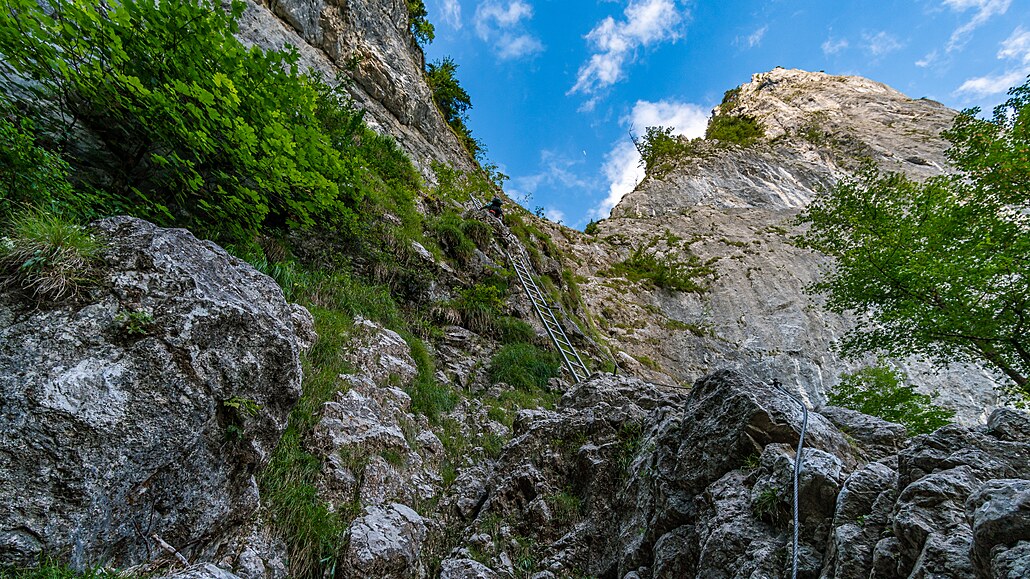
[797,74,1030,397]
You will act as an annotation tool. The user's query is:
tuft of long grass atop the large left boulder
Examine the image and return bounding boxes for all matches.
[0,210,101,302]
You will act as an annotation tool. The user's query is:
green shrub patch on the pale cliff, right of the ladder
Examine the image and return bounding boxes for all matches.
[605,238,716,294]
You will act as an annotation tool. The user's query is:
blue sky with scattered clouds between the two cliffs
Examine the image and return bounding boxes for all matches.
[425,0,1030,229]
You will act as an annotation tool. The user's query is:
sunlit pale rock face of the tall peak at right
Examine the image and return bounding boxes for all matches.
[553,69,998,423]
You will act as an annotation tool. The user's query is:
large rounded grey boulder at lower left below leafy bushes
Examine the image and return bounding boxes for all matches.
[0,217,313,567]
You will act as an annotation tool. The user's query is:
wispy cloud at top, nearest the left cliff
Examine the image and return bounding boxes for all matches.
[475,0,544,60]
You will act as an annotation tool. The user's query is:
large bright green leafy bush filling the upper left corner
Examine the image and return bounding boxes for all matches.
[0,0,401,240]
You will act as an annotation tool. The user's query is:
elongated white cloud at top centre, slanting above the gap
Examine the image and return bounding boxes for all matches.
[569,0,687,94]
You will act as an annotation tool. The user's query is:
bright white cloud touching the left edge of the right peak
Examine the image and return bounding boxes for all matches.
[590,101,709,219]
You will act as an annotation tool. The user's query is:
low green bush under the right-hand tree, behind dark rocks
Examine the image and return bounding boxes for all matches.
[829,366,955,436]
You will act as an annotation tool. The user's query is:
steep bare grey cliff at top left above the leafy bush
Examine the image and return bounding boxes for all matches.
[238,0,473,178]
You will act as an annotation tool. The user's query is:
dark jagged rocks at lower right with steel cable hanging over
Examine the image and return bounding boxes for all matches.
[442,371,1030,579]
